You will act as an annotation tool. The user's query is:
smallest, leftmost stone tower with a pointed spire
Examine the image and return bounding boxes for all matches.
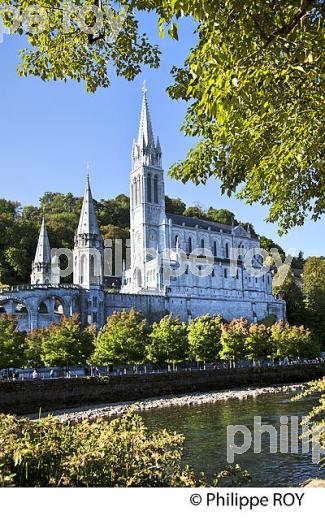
[31,217,60,285]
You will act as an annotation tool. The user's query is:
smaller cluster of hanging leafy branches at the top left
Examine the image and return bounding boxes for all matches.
[3,0,160,92]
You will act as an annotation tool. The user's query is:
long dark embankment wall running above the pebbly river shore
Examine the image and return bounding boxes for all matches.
[0,364,325,414]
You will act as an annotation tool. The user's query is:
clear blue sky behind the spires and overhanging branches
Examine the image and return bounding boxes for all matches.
[0,16,325,256]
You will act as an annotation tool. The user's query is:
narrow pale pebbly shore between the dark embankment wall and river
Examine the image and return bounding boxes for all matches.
[39,383,306,422]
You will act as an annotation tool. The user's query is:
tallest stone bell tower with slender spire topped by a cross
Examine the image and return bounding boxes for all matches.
[130,83,166,288]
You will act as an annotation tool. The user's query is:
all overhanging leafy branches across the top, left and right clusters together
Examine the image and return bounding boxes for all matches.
[3,0,325,232]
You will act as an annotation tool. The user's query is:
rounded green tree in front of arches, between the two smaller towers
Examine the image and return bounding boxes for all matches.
[41,315,94,366]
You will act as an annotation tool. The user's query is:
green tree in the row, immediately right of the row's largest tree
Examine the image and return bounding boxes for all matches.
[147,316,188,366]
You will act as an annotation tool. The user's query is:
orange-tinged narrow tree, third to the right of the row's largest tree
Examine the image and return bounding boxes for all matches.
[220,318,249,366]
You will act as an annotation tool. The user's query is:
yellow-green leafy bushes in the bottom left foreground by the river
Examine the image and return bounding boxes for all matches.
[0,410,196,487]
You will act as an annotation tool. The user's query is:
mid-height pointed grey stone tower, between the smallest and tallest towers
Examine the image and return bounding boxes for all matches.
[73,176,103,289]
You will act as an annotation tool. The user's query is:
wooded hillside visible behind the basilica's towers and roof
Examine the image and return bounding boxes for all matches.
[0,192,264,288]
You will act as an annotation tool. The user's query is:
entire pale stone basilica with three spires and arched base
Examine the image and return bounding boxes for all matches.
[0,83,285,330]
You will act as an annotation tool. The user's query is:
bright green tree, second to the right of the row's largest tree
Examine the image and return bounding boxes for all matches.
[187,315,222,362]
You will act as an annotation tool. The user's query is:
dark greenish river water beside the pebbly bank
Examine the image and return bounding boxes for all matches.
[142,393,325,487]
